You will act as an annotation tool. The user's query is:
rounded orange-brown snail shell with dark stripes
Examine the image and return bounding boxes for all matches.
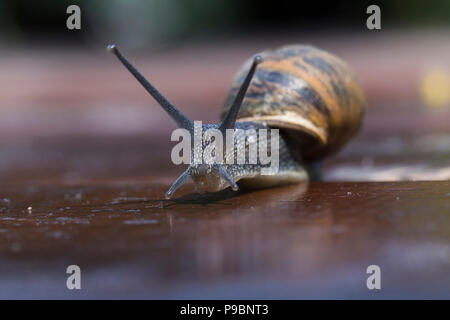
[222,45,365,160]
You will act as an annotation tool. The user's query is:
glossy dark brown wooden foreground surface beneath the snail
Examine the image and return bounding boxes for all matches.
[0,182,450,298]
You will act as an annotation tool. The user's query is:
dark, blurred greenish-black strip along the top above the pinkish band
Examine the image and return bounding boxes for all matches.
[0,0,450,47]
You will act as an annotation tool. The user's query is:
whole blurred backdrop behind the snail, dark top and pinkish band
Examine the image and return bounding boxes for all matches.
[0,0,450,183]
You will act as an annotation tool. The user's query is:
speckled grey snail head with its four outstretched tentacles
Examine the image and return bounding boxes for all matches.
[107,45,262,199]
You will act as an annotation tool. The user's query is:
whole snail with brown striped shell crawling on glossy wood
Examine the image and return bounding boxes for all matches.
[107,45,365,199]
